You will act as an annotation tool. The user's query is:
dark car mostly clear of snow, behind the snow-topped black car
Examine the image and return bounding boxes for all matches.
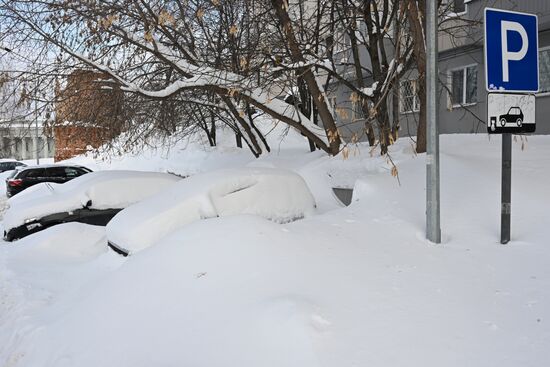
[6,165,92,197]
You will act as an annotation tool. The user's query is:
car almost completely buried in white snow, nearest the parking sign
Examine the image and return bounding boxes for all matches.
[106,168,315,256]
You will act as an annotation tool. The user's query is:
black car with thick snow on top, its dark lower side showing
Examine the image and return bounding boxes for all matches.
[4,171,180,241]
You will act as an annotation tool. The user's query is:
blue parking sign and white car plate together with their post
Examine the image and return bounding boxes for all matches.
[485,8,539,244]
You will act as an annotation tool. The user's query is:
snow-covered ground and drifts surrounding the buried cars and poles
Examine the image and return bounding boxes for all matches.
[0,127,550,367]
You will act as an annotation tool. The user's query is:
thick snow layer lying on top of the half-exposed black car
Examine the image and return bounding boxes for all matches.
[4,171,180,230]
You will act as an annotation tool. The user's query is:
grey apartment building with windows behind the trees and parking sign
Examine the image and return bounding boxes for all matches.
[330,0,550,141]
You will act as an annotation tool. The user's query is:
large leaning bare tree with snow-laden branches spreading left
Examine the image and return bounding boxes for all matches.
[1,0,339,155]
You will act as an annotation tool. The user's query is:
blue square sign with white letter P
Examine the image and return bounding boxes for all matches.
[485,8,539,93]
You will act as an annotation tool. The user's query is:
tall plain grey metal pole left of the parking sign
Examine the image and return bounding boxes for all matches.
[426,0,441,243]
